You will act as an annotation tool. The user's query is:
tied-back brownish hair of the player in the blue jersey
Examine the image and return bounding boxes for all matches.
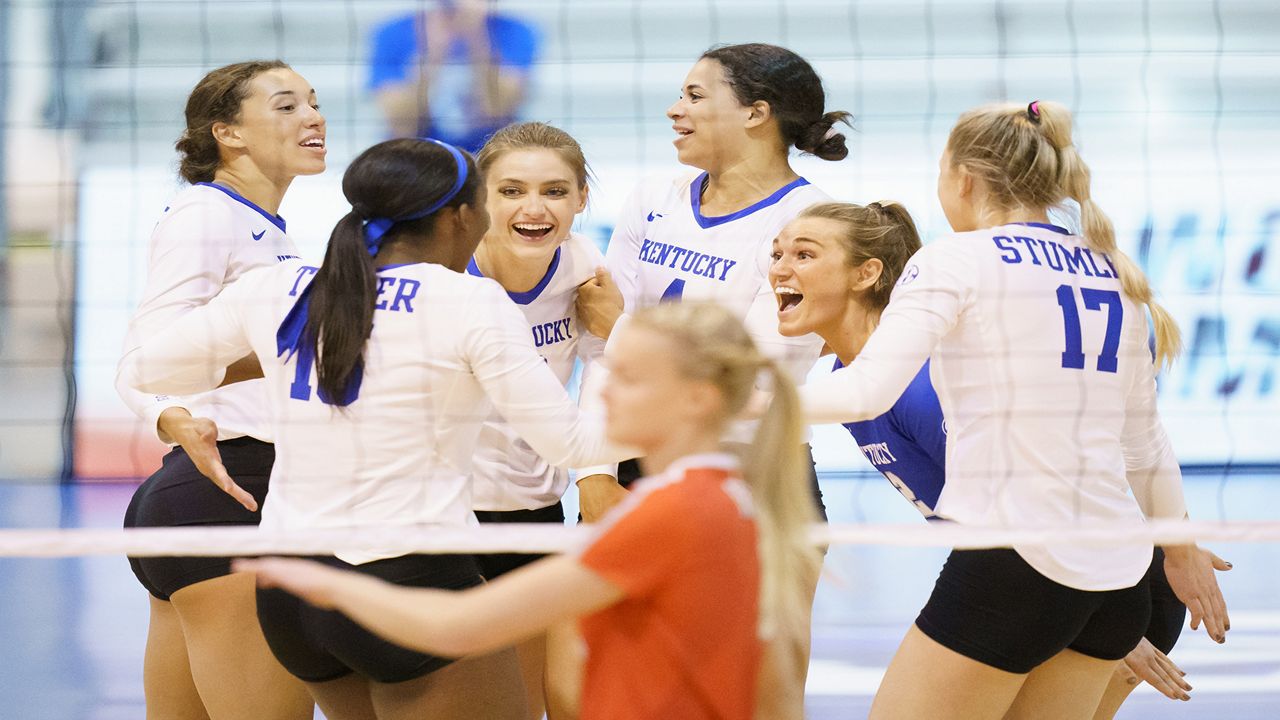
[796,200,920,310]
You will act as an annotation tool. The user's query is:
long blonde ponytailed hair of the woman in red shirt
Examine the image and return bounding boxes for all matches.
[631,302,820,691]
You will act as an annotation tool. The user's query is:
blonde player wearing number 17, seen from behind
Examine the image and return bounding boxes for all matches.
[785,102,1226,719]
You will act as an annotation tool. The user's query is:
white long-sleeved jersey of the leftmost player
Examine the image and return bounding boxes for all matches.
[115,183,298,442]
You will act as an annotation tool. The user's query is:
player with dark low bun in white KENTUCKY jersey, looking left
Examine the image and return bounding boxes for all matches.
[577,44,850,520]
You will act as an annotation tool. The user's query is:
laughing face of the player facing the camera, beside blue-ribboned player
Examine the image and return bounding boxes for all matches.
[484,147,586,265]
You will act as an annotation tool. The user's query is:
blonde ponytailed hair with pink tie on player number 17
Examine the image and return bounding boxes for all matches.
[947,100,1181,366]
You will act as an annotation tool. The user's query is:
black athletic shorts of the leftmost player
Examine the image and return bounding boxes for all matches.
[124,437,275,600]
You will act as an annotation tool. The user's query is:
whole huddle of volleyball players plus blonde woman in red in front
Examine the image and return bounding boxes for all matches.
[116,44,1230,720]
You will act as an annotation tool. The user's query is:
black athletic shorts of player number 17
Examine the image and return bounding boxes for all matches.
[915,548,1151,673]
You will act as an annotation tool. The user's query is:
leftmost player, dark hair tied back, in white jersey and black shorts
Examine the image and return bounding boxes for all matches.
[116,60,325,720]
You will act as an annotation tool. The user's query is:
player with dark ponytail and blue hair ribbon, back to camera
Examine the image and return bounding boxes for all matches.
[122,140,626,720]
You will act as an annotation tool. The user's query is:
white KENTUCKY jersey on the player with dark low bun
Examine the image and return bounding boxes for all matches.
[605,173,831,383]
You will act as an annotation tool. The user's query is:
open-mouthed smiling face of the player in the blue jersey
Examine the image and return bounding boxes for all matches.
[769,217,864,338]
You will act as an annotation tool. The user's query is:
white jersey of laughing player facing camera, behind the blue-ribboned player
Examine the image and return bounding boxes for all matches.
[467,234,604,511]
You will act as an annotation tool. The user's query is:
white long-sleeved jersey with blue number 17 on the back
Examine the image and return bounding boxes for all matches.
[801,224,1185,591]
